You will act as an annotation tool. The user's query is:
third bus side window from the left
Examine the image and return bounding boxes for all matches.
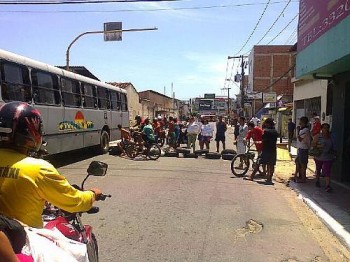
[61,78,81,107]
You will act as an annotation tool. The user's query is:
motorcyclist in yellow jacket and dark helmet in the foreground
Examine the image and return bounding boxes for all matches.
[0,102,102,251]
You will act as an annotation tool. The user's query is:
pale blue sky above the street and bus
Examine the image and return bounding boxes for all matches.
[0,0,299,99]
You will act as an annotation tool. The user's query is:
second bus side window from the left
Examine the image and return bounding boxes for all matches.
[31,69,61,105]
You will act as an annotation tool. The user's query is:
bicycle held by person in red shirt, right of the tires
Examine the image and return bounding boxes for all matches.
[231,141,264,177]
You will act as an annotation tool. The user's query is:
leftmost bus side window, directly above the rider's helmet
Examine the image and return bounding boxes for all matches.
[1,62,32,103]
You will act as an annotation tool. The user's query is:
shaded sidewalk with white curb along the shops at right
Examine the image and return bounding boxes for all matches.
[278,141,350,250]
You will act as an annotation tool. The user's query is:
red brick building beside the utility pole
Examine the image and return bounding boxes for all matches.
[246,45,295,115]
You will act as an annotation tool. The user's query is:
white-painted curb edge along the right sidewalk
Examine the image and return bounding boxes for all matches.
[290,184,350,250]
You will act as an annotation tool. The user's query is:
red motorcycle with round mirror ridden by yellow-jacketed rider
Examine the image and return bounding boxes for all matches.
[20,161,111,262]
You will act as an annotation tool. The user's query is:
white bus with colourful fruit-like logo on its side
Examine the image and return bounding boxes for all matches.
[0,50,129,154]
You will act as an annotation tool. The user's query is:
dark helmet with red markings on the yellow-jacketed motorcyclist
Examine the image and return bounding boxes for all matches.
[0,102,43,152]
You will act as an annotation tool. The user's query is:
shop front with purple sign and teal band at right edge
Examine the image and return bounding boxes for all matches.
[295,0,350,181]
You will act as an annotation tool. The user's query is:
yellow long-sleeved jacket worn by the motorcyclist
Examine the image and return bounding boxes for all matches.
[0,148,94,227]
